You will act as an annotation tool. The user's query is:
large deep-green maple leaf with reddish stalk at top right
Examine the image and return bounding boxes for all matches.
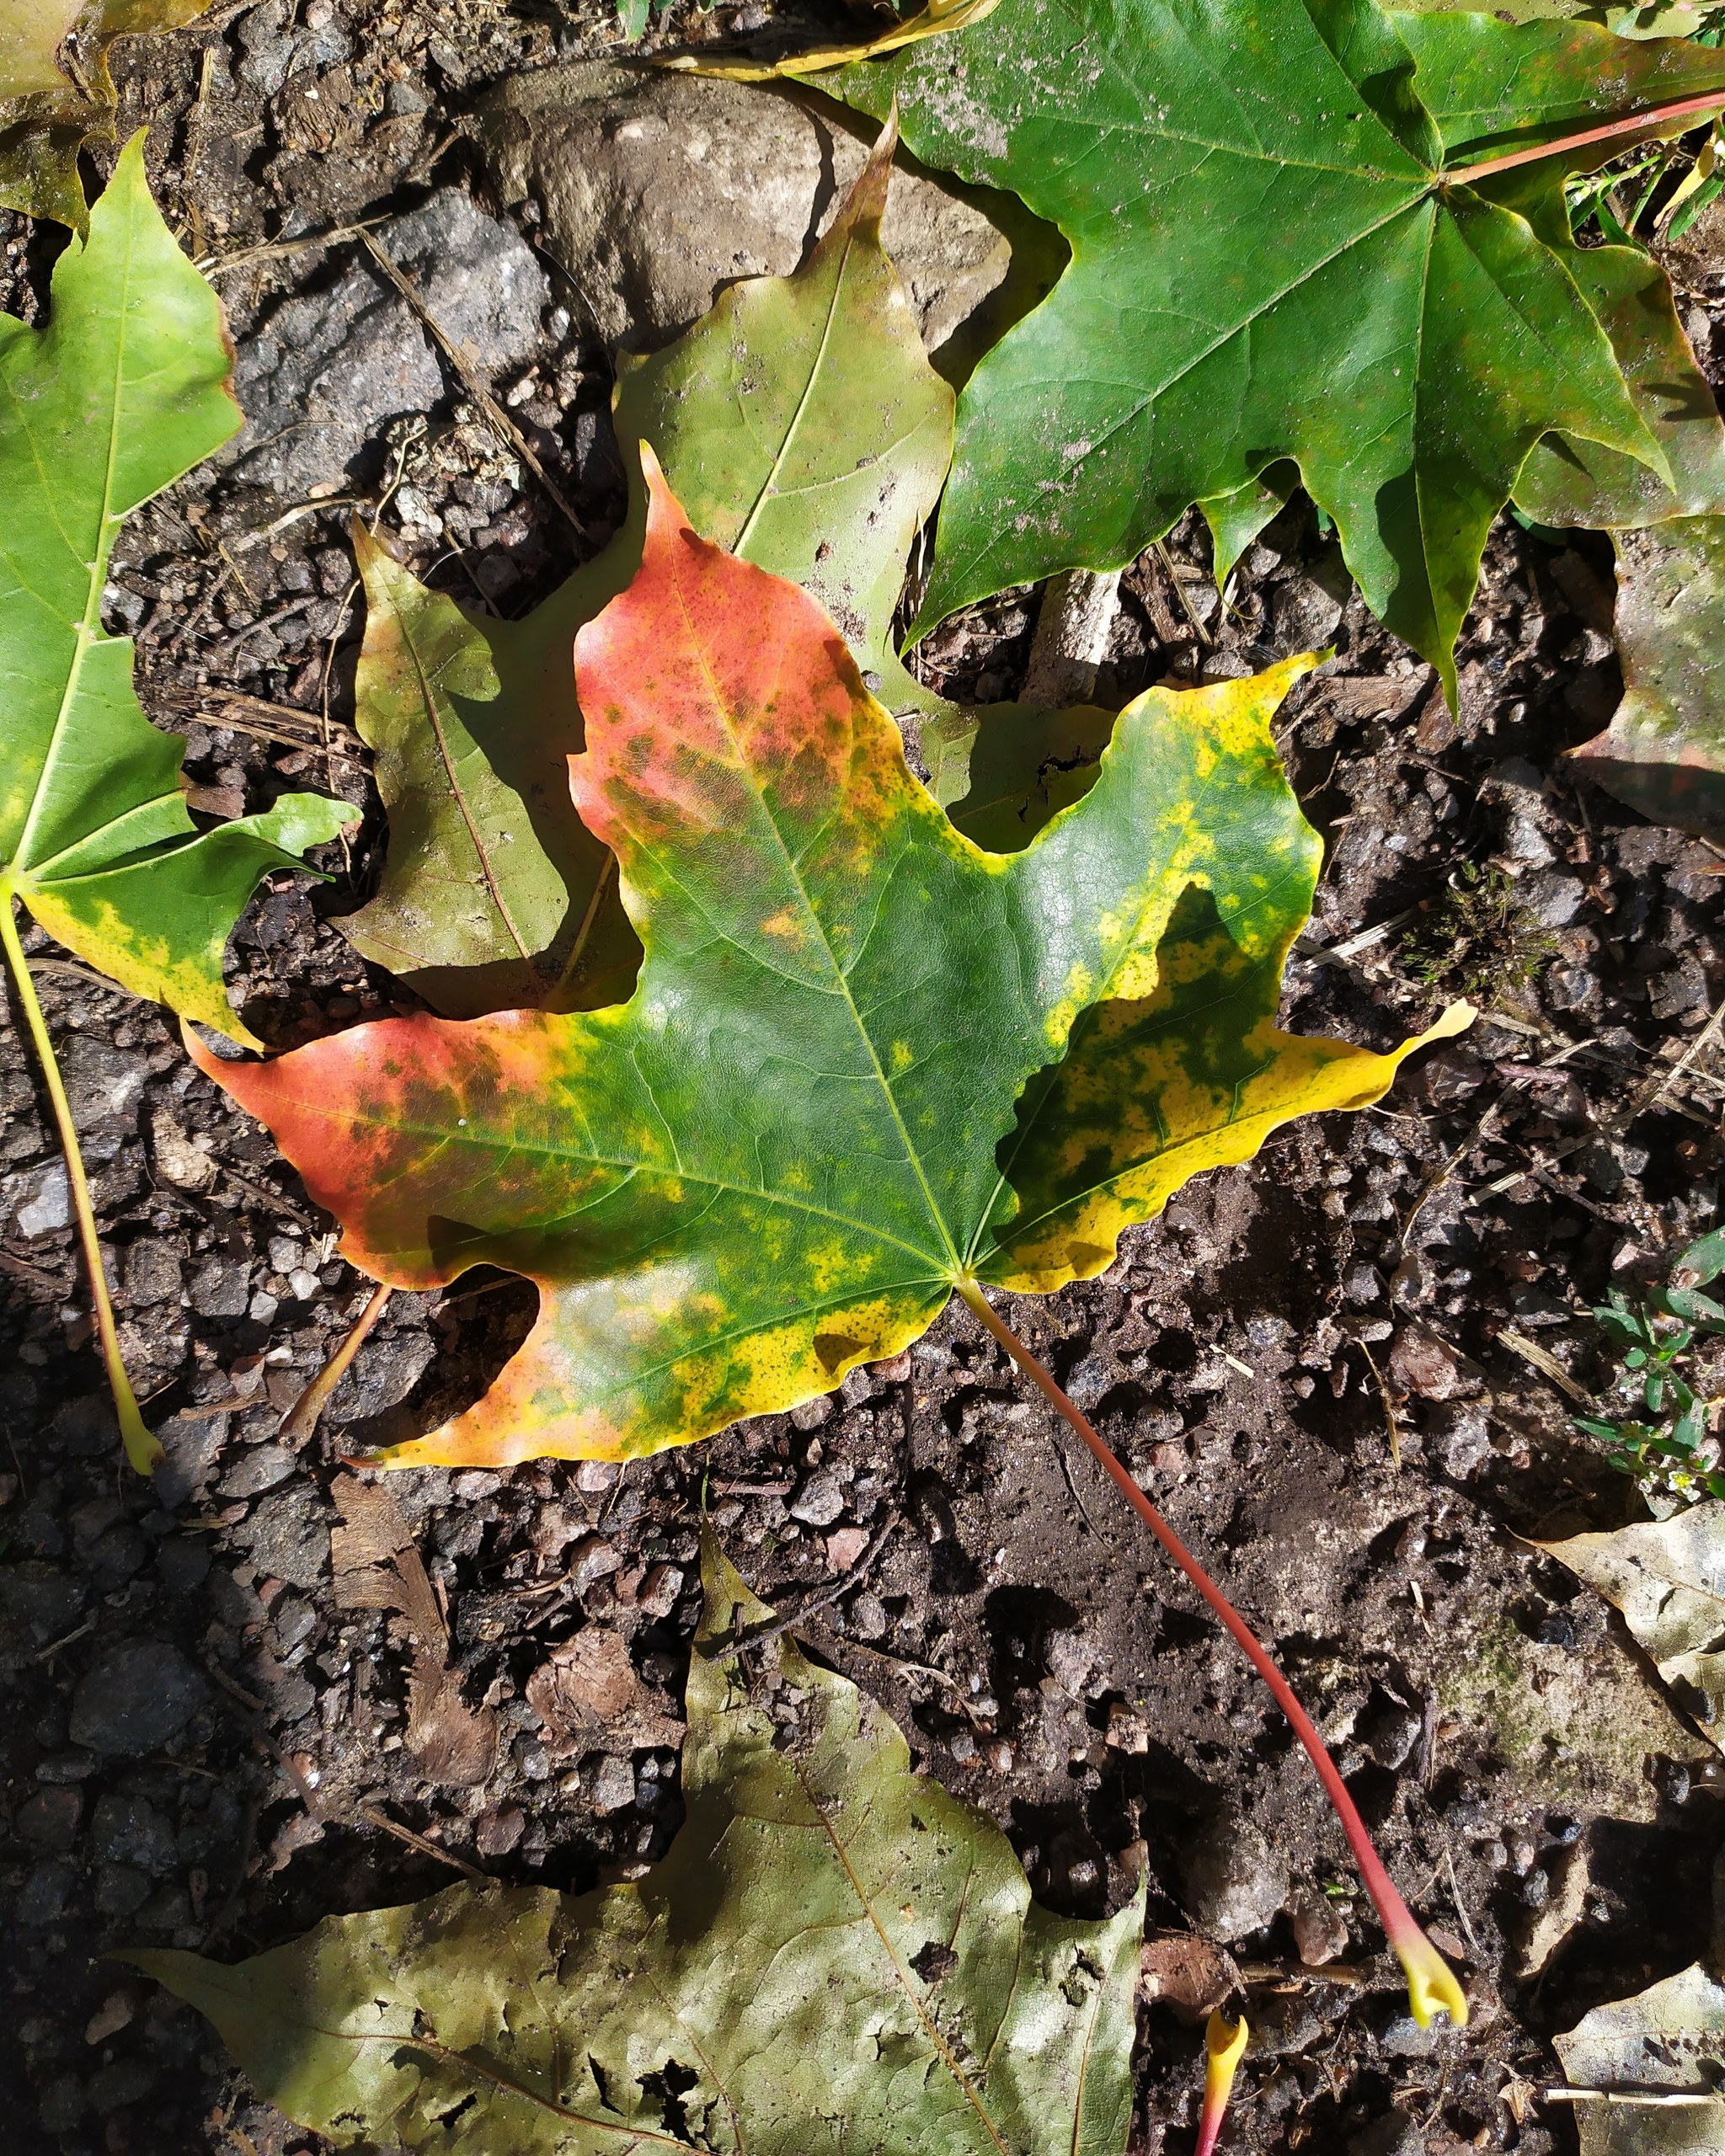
[820,0,1725,684]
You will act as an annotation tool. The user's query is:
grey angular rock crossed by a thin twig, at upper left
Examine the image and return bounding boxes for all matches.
[235,188,550,498]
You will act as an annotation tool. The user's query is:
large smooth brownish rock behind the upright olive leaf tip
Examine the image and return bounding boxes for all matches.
[478,61,1012,351]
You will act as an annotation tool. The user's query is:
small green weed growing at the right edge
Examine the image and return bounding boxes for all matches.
[1576,1229,1725,1505]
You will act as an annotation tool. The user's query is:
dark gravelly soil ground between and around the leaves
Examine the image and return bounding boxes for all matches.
[0,0,1725,2156]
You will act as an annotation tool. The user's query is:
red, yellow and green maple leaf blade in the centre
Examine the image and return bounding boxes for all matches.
[189,455,1464,1464]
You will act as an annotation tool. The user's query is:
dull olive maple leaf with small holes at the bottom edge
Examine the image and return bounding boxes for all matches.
[130,1544,1143,2156]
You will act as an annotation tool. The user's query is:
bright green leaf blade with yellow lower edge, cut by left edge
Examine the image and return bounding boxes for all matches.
[0,136,355,1046]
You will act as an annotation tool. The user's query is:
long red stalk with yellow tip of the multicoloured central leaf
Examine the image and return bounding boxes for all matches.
[955,1281,1468,2029]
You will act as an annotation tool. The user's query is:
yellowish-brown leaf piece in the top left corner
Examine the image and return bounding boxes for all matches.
[0,0,209,232]
